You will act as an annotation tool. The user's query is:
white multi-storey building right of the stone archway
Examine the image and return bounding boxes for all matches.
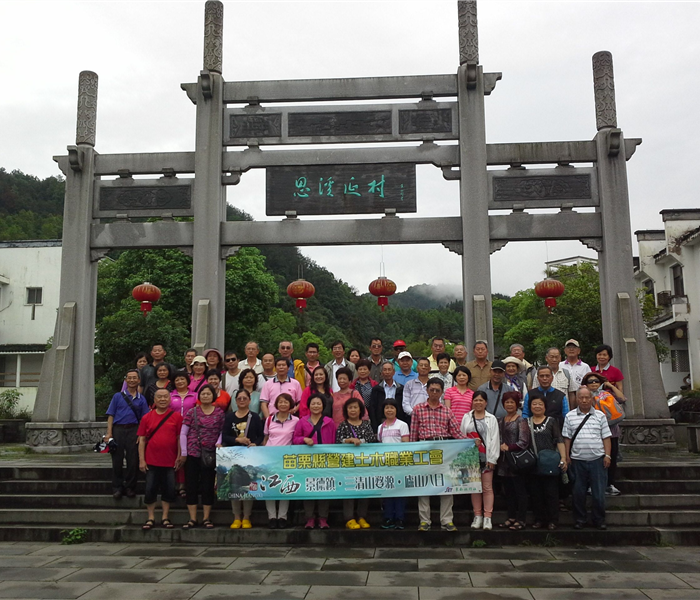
[634,209,700,392]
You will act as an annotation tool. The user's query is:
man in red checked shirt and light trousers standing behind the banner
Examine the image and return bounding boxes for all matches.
[409,378,464,531]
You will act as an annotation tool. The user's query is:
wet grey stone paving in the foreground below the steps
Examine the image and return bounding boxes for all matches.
[0,542,700,600]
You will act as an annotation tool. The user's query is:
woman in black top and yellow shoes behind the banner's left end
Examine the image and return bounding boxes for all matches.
[221,390,265,529]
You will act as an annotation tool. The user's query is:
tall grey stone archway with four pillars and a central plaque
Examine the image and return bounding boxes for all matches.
[27,0,673,452]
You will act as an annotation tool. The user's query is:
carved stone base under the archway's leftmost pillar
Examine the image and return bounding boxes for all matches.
[26,421,107,454]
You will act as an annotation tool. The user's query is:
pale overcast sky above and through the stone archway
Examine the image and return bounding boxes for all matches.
[0,0,700,294]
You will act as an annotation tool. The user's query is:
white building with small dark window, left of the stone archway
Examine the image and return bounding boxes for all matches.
[0,240,61,408]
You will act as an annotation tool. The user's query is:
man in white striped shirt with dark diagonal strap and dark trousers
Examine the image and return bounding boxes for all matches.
[562,386,611,529]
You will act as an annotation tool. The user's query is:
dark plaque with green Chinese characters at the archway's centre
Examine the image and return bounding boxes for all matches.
[266,163,416,216]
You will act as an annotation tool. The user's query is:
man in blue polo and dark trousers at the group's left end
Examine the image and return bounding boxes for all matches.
[103,369,148,500]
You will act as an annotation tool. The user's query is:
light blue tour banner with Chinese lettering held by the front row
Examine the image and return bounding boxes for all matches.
[216,439,481,500]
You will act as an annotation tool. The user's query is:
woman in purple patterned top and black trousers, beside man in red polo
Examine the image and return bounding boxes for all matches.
[180,384,224,529]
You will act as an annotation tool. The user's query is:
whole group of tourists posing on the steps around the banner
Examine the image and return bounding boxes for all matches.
[105,337,625,531]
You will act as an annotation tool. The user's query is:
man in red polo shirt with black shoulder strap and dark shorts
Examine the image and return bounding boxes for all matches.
[137,388,182,530]
